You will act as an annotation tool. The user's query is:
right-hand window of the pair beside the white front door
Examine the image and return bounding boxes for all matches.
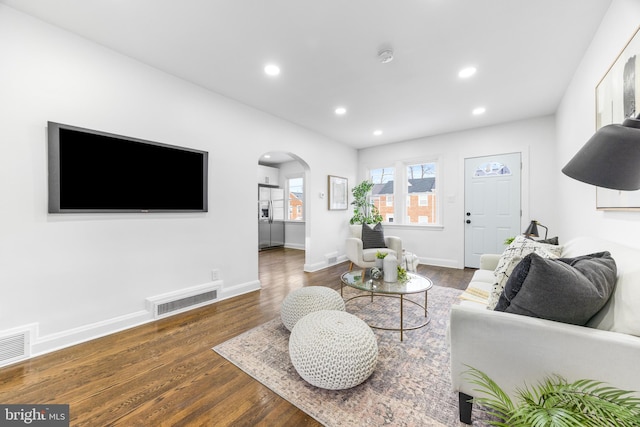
[406,163,438,224]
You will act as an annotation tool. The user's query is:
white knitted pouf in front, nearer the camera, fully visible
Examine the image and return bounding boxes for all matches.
[289,310,378,390]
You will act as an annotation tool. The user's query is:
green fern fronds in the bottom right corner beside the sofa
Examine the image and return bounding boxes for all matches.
[466,367,640,427]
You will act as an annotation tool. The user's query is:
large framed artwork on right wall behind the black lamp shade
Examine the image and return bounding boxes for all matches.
[596,28,640,210]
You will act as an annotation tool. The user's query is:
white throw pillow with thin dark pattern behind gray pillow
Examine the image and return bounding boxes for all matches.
[487,236,562,310]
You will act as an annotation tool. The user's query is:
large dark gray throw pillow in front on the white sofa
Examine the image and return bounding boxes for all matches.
[495,252,617,325]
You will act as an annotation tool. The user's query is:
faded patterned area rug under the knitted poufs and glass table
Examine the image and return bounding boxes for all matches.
[213,286,489,427]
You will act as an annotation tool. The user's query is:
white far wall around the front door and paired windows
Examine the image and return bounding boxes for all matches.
[358,116,557,268]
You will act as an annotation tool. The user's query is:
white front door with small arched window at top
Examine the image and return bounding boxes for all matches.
[464,153,521,268]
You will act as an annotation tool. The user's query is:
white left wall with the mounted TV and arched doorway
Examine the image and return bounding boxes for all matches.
[0,5,357,353]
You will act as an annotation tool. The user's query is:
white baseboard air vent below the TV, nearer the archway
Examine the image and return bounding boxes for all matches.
[147,285,220,319]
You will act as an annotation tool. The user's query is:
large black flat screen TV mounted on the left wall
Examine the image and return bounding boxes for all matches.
[48,122,208,213]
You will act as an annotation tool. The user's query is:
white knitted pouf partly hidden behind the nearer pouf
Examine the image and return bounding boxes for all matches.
[280,286,344,330]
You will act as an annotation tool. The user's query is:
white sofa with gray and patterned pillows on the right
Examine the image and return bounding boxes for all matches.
[449,237,640,424]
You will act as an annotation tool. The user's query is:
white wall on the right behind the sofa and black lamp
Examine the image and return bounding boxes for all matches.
[555,0,640,247]
